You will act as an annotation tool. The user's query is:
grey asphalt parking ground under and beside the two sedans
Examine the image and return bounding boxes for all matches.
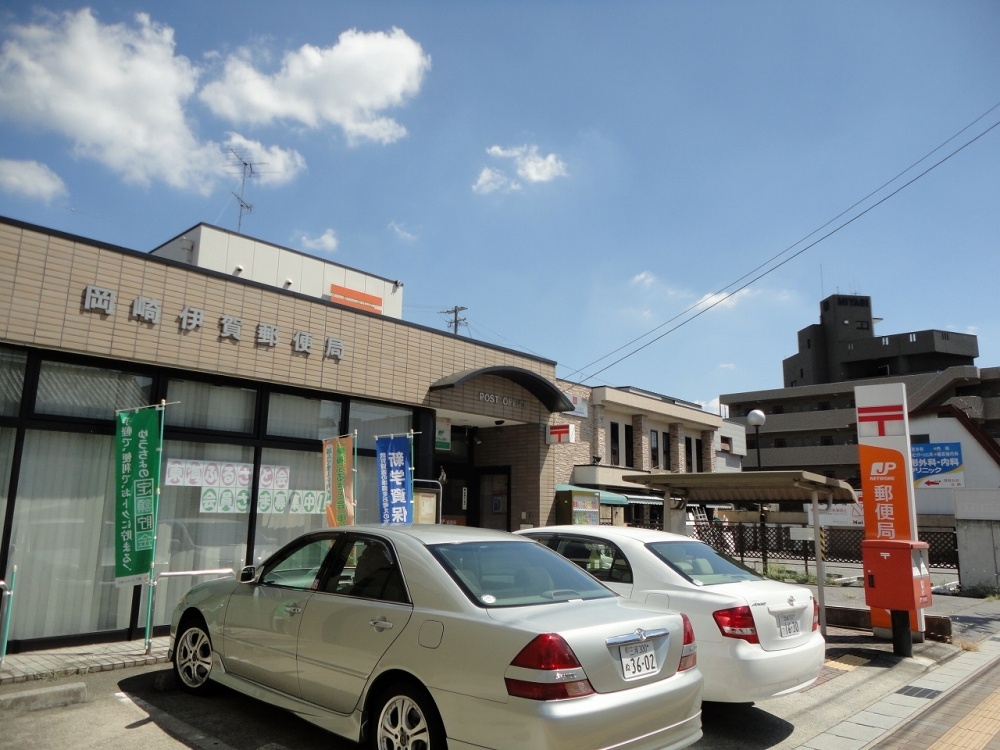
[0,652,928,750]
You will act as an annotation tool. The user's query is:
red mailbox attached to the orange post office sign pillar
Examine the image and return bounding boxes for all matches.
[861,539,931,612]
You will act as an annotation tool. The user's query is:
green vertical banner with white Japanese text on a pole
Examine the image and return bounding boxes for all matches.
[115,407,161,586]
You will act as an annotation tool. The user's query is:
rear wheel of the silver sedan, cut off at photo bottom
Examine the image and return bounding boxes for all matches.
[371,683,447,750]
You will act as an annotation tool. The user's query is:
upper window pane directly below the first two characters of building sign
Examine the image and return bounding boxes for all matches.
[35,362,153,420]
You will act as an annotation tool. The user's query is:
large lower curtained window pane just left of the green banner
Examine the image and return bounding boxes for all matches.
[10,430,126,639]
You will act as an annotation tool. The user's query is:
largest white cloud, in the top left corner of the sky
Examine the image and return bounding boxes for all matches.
[0,9,225,193]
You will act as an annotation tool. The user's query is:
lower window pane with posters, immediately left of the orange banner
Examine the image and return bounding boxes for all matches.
[254,448,329,560]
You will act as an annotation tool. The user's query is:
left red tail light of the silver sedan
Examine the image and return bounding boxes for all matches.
[504,633,594,701]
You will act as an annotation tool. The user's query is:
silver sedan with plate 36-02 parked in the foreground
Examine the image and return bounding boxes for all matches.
[171,525,702,750]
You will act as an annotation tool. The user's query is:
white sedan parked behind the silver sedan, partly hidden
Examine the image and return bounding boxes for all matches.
[517,525,826,703]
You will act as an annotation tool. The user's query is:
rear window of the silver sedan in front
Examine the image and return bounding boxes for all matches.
[431,542,615,607]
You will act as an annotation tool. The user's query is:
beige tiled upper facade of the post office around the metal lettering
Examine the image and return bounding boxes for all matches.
[0,221,554,414]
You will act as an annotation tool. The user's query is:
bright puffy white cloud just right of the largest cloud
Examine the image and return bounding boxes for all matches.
[199,28,431,143]
